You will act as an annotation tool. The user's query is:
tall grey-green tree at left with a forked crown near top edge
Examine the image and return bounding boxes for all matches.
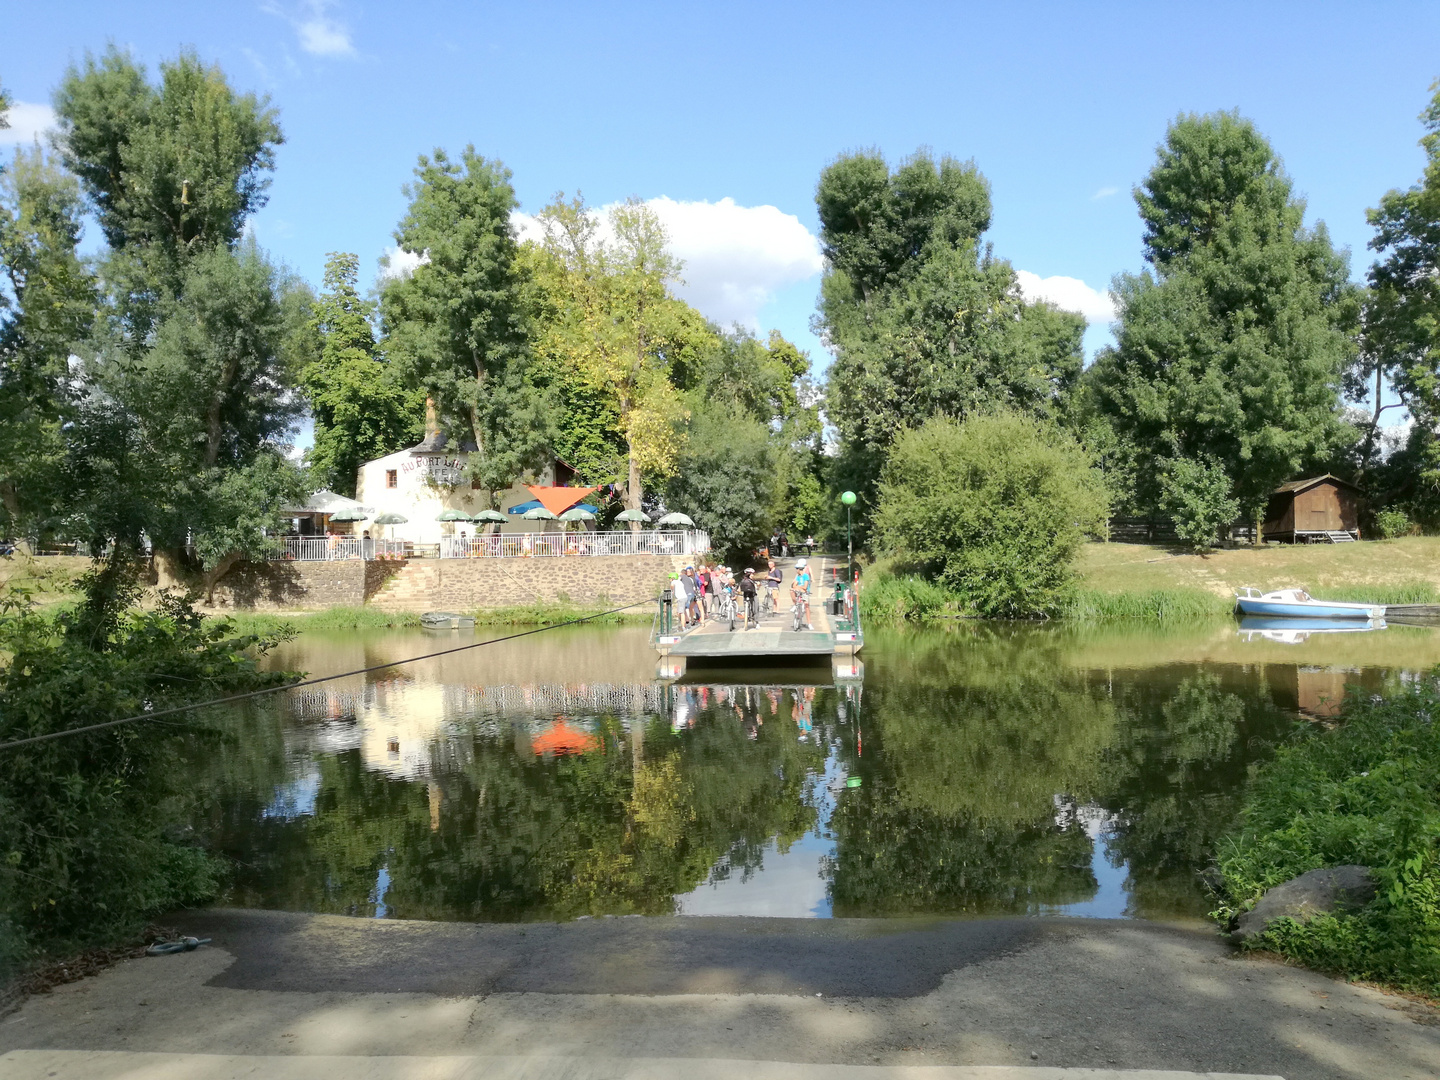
[56,48,304,589]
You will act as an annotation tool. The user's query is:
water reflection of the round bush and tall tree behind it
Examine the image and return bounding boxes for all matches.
[831,625,1115,916]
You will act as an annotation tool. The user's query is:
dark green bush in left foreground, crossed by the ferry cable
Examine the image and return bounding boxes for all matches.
[0,566,285,975]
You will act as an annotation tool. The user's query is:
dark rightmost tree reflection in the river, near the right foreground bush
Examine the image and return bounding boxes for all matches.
[1099,667,1293,916]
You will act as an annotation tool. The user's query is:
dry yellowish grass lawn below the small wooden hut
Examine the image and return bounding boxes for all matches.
[1076,536,1440,603]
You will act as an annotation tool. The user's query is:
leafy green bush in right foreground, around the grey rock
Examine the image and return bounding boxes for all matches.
[1215,670,1440,995]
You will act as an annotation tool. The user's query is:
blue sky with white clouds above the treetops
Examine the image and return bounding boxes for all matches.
[0,0,1440,377]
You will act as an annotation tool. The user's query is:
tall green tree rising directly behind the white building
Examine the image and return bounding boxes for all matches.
[380,147,550,491]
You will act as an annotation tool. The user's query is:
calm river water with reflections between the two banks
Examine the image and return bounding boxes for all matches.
[194,622,1440,920]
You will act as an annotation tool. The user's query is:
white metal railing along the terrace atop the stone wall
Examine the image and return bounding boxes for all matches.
[274,528,710,563]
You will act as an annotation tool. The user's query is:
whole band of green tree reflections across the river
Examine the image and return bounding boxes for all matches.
[197,624,1324,919]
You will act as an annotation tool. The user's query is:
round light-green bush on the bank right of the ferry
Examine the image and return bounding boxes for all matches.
[876,413,1110,618]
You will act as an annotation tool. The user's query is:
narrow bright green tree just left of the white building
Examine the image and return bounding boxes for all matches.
[300,252,425,495]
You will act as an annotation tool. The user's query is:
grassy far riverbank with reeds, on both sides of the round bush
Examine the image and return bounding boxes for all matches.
[861,536,1440,622]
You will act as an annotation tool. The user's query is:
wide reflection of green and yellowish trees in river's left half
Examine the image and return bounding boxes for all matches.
[206,694,824,920]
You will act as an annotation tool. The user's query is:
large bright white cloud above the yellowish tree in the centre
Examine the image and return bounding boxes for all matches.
[513,196,825,331]
